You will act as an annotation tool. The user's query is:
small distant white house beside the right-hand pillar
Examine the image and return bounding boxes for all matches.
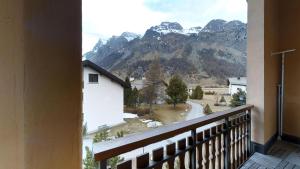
[228,77,247,95]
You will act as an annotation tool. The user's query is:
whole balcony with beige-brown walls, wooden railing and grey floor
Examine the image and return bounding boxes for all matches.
[0,0,300,169]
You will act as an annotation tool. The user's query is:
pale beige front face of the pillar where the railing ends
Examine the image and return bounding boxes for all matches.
[247,0,264,144]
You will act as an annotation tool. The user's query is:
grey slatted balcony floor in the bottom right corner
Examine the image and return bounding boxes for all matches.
[241,141,300,169]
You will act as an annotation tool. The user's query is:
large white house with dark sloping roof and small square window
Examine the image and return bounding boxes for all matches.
[82,60,126,133]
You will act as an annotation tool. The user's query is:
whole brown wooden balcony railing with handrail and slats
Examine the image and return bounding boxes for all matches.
[94,105,253,169]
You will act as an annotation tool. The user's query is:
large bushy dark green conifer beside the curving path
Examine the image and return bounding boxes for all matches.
[166,75,188,108]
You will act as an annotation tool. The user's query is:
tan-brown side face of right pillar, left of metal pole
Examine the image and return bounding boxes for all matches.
[264,0,281,142]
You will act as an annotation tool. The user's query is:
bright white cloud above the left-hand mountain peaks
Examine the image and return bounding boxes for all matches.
[82,0,168,52]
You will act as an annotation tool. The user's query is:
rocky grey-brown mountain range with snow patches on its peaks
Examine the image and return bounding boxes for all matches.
[85,19,247,84]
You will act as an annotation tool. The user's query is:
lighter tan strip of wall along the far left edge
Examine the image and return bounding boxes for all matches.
[0,0,24,169]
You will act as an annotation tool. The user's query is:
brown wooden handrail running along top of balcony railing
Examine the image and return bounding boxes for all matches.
[94,105,254,161]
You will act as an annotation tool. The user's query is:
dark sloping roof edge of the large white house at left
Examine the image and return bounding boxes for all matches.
[82,60,128,88]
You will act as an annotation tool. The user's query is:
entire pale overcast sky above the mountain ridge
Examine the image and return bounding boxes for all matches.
[82,0,247,53]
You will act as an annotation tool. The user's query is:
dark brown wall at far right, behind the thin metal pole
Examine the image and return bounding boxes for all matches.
[280,0,300,137]
